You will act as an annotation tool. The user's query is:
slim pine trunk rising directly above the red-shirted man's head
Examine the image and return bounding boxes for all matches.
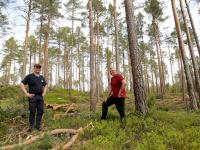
[114,0,120,71]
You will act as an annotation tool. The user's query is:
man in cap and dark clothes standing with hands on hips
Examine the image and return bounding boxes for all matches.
[20,64,47,132]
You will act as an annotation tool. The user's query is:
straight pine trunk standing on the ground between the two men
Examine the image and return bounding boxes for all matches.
[88,0,96,112]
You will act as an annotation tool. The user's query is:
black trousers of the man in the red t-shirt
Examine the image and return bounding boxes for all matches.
[101,96,125,121]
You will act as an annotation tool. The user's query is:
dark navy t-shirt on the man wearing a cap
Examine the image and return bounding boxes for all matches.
[22,73,47,95]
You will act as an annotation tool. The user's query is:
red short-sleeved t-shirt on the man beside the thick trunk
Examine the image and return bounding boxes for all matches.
[111,74,126,98]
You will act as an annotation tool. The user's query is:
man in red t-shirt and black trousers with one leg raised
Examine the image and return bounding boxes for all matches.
[101,68,126,125]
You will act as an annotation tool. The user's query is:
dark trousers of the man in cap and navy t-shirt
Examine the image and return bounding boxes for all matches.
[29,95,44,128]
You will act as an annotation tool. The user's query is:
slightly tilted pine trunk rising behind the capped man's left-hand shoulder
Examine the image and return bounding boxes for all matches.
[22,0,32,78]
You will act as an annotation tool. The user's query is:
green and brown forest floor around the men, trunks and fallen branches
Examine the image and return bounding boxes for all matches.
[0,87,200,150]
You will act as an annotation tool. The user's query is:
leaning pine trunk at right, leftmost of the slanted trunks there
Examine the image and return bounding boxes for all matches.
[171,0,198,110]
